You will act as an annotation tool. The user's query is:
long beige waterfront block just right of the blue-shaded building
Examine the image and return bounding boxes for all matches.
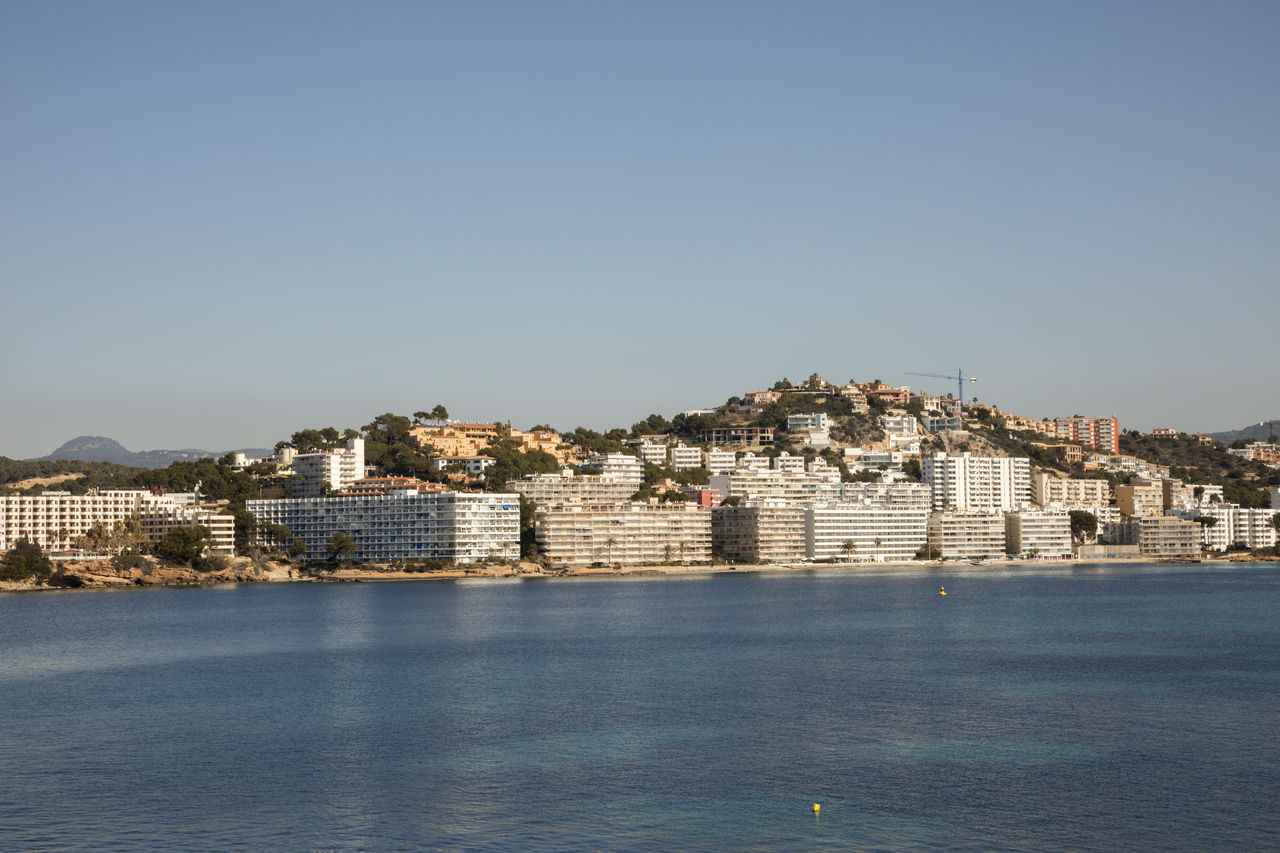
[534,502,712,567]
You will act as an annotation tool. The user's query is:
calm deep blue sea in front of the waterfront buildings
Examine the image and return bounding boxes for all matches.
[0,564,1280,852]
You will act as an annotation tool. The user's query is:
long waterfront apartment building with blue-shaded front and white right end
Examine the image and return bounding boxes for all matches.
[246,489,520,562]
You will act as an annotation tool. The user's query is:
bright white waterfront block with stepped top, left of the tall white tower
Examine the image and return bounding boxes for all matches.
[805,483,929,562]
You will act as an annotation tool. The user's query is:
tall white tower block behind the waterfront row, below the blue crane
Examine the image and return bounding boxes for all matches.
[920,453,1032,514]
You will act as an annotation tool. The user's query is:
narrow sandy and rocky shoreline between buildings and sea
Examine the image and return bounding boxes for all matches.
[0,555,1280,593]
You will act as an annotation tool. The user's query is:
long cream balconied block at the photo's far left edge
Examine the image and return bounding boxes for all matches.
[0,489,236,555]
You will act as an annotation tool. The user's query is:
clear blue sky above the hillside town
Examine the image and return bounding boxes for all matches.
[0,0,1280,459]
